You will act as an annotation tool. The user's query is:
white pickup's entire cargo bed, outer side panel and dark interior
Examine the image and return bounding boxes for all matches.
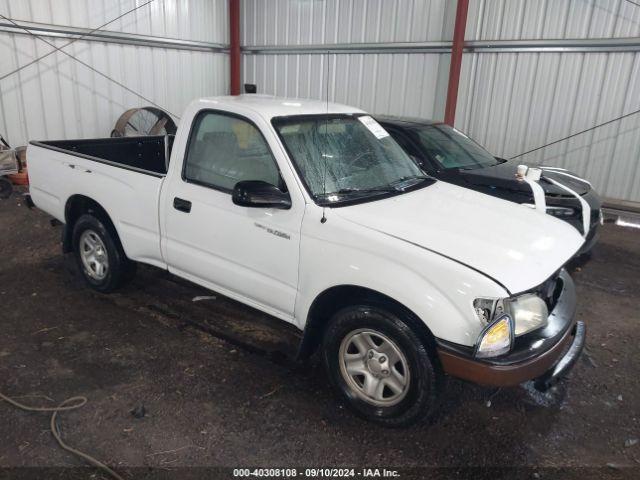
[27,136,173,268]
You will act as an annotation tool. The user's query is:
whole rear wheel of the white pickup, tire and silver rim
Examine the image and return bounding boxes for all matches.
[73,214,135,293]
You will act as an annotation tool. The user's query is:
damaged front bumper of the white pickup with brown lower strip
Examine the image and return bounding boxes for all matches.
[438,272,586,390]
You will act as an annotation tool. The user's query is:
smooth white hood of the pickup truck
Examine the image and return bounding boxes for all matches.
[334,182,583,294]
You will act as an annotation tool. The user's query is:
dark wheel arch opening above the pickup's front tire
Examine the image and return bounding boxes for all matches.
[298,285,437,361]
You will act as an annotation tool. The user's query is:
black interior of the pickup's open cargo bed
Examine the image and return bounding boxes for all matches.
[31,135,174,176]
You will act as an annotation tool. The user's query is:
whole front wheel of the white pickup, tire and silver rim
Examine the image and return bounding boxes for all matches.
[323,305,440,427]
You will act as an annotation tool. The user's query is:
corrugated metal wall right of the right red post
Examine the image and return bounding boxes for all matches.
[456,0,640,202]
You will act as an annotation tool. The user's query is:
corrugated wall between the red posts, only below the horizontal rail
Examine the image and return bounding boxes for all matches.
[243,53,448,118]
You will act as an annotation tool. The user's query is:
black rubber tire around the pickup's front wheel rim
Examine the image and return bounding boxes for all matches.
[323,305,442,427]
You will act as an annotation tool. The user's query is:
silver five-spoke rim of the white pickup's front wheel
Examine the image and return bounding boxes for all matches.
[340,329,409,407]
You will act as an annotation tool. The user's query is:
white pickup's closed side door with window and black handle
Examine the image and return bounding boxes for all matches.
[163,110,304,321]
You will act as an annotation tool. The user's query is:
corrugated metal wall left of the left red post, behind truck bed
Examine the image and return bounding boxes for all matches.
[0,0,229,145]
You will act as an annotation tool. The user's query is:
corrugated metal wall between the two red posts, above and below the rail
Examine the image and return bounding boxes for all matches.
[241,0,455,117]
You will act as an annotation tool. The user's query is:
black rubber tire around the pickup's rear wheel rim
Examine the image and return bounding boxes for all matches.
[72,213,136,293]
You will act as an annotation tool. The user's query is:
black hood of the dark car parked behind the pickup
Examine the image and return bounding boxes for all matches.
[458,160,590,197]
